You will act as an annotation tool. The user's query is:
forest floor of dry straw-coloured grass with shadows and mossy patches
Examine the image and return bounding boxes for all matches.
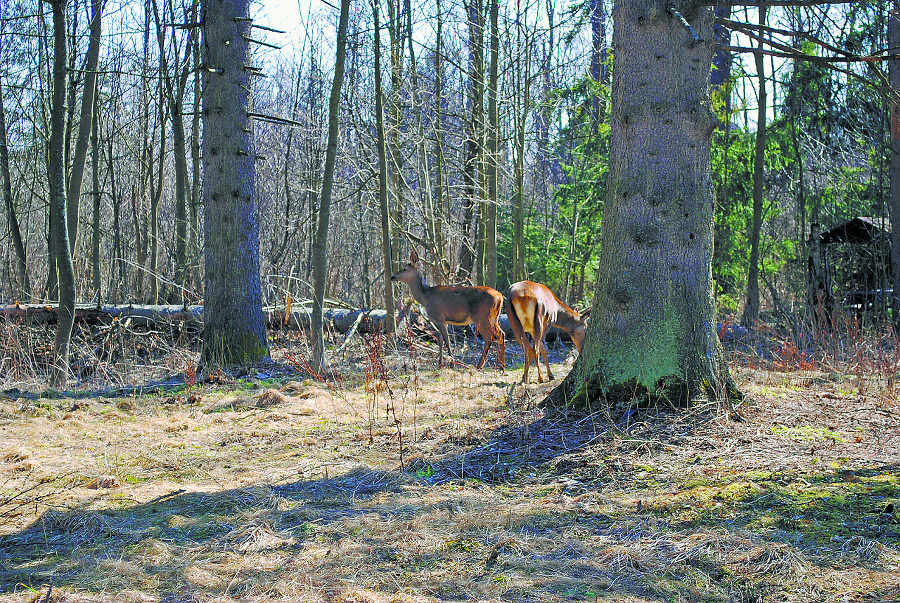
[0,326,900,603]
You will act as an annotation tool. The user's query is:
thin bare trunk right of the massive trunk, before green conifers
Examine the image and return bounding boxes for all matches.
[741,4,766,329]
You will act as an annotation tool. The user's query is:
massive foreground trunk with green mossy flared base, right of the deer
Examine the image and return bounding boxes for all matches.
[549,0,728,407]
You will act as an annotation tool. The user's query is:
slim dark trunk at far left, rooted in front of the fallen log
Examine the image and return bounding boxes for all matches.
[49,0,75,387]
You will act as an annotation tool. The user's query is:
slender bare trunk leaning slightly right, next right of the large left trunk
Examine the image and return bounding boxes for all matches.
[312,0,350,371]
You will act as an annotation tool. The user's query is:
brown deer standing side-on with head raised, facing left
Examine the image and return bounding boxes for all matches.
[391,250,506,368]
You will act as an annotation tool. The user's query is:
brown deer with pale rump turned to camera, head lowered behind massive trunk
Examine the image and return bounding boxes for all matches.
[506,281,591,383]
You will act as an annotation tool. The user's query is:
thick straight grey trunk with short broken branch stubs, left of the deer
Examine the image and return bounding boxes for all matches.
[201,0,268,368]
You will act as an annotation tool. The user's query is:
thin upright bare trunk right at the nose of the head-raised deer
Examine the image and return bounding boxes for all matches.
[372,0,397,336]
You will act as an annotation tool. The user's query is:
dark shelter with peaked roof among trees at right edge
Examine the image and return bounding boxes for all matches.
[809,217,892,322]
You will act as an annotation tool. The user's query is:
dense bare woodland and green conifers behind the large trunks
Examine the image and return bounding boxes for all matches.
[0,1,890,346]
